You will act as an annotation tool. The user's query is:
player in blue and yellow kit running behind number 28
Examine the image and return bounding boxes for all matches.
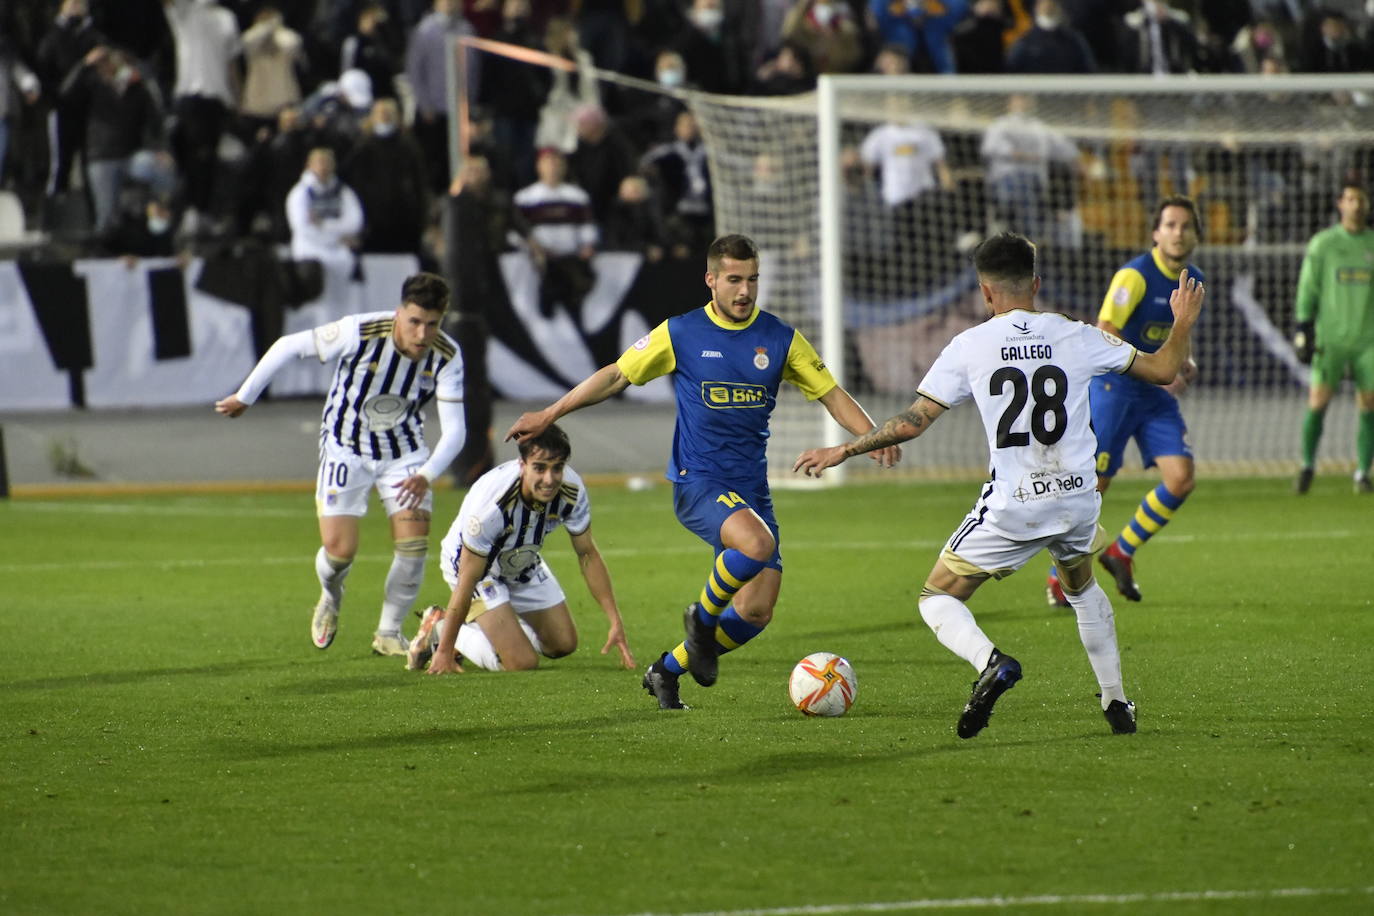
[1047,196,1204,607]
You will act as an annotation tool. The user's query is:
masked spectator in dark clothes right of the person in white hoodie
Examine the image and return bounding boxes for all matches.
[339,99,430,254]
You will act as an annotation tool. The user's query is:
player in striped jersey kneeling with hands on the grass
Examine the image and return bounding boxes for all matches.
[405,426,635,674]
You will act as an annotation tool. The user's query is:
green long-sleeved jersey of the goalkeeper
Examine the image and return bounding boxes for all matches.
[1297,224,1374,349]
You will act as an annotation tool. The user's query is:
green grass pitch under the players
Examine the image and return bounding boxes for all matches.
[0,478,1374,916]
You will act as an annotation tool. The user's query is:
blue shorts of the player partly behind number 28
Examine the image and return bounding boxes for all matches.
[1088,375,1193,477]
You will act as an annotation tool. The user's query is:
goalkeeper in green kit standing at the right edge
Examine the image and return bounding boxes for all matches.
[1293,183,1374,493]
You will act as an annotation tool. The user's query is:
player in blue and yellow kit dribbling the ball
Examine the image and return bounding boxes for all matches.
[506,235,901,709]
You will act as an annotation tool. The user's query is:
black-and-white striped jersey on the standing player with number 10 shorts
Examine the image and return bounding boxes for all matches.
[313,312,463,459]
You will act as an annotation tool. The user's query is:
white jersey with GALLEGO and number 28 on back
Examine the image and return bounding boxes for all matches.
[918,309,1136,540]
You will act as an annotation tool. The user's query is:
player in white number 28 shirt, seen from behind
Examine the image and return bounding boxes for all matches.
[793,232,1204,737]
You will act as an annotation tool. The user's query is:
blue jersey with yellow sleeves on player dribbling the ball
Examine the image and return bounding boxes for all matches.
[616,304,835,493]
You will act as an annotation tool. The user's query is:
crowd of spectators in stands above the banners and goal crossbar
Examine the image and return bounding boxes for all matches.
[0,0,1374,269]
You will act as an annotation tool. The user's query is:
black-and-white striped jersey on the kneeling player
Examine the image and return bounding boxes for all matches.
[441,460,592,582]
